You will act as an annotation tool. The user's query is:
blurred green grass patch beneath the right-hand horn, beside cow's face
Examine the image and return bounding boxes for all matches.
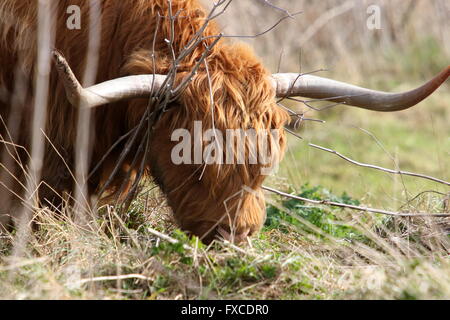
[279,92,450,207]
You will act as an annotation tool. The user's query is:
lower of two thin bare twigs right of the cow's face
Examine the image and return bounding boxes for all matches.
[262,186,450,218]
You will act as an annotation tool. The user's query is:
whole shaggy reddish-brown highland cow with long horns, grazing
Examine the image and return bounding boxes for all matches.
[0,0,450,242]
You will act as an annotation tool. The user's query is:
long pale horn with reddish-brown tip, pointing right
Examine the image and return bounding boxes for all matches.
[272,66,450,112]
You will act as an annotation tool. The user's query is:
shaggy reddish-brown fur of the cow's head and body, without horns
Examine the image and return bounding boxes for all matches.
[0,0,288,241]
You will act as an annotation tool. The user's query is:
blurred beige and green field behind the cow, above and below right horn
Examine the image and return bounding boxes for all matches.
[210,0,450,210]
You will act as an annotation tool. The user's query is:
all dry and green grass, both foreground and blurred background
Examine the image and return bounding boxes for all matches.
[0,0,450,300]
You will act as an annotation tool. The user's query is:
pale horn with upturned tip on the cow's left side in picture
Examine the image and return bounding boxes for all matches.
[53,50,167,108]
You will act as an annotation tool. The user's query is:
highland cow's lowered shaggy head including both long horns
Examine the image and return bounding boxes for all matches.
[55,45,450,242]
